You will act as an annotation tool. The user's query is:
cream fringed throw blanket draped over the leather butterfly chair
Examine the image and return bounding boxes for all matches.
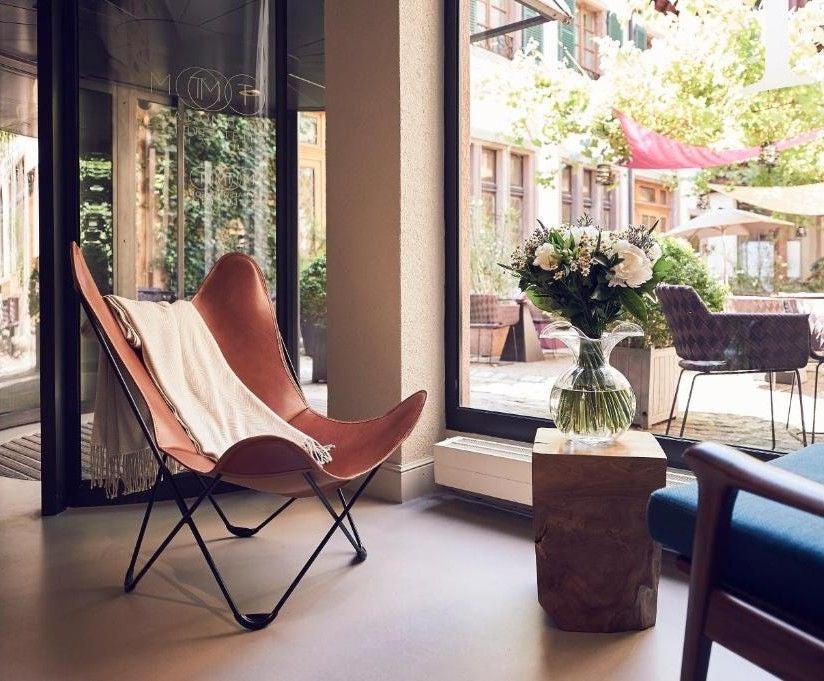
[91,296,333,496]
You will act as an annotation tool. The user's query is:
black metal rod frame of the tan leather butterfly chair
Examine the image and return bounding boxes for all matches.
[83,301,378,631]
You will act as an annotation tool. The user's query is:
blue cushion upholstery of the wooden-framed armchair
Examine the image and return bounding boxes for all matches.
[647,444,824,632]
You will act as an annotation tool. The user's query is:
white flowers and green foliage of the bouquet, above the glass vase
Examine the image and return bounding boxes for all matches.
[503,216,669,338]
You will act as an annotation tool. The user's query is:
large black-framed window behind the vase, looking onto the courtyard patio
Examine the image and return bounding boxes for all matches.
[446,0,824,456]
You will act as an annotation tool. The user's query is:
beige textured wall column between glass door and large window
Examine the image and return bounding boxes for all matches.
[325,0,444,501]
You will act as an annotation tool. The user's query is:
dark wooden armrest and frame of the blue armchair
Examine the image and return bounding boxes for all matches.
[679,442,824,681]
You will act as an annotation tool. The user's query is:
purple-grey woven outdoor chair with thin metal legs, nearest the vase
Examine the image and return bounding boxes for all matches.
[656,284,810,449]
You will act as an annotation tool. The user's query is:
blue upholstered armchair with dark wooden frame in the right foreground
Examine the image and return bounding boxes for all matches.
[647,443,824,681]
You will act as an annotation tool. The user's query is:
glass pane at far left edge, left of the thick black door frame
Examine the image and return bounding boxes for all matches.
[0,0,40,444]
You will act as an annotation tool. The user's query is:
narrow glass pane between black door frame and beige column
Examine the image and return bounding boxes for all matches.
[298,112,327,414]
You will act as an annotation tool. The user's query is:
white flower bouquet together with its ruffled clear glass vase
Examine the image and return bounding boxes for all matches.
[503,217,668,443]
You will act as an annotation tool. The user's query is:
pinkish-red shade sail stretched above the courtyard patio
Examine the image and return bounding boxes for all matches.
[615,111,821,170]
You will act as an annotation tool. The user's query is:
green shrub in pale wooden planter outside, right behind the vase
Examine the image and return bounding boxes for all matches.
[612,238,729,428]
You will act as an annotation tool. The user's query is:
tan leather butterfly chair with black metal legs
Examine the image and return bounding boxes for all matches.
[71,244,426,630]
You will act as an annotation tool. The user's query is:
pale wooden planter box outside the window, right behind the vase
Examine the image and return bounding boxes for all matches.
[610,345,680,428]
